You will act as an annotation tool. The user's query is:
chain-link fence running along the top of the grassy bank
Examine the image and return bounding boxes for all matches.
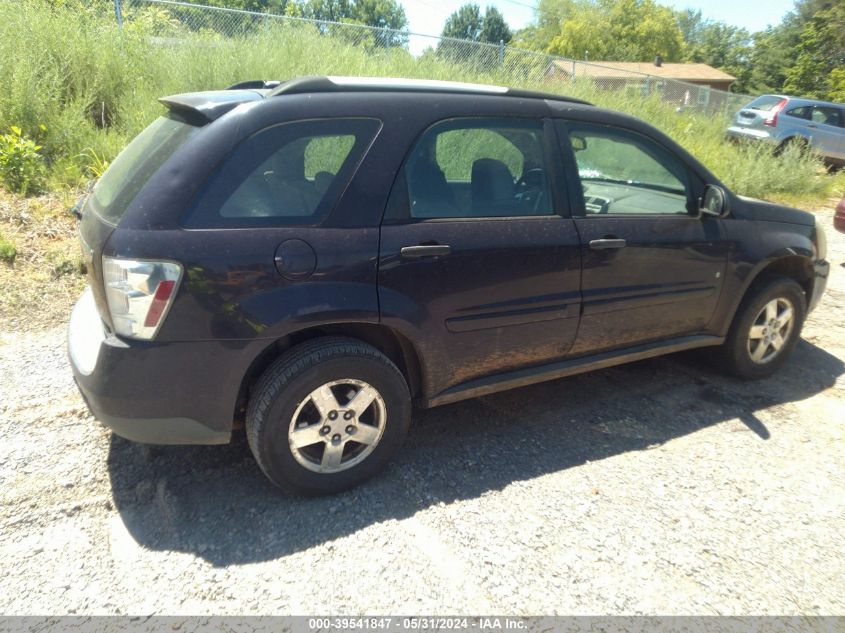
[115,0,752,115]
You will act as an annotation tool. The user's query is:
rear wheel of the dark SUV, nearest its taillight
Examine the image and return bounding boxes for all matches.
[246,338,411,494]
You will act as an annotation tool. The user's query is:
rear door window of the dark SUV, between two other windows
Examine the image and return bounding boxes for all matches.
[403,119,552,219]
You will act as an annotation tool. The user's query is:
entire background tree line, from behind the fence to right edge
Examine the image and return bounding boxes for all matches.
[64,0,845,101]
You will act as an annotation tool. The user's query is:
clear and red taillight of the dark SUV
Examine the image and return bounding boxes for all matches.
[103,257,182,341]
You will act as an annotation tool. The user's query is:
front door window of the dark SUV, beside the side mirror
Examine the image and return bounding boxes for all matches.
[569,124,691,215]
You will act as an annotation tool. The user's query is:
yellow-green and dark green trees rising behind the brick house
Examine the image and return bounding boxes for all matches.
[514,0,845,101]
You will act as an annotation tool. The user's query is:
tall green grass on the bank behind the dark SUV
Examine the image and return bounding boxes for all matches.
[0,0,845,201]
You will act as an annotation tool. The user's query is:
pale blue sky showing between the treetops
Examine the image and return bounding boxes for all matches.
[399,0,794,54]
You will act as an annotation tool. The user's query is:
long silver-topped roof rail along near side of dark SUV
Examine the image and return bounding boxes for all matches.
[268,75,593,105]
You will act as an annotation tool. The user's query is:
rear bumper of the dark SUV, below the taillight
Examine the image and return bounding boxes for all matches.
[68,289,243,444]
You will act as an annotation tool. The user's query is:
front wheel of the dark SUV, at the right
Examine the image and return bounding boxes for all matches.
[719,275,807,380]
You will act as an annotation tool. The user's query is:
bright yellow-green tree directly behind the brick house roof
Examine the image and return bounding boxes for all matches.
[547,0,684,61]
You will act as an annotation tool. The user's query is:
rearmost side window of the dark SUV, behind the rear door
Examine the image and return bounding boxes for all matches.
[188,119,380,228]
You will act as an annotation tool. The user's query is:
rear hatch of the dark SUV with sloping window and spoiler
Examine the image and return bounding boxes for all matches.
[76,90,266,329]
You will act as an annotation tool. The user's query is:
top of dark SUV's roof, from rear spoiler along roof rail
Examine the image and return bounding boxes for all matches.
[159,76,592,121]
